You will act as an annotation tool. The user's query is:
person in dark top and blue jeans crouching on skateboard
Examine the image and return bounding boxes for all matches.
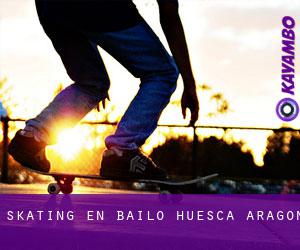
[9,0,199,179]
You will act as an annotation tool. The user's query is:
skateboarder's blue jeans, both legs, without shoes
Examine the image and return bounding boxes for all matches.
[26,22,178,150]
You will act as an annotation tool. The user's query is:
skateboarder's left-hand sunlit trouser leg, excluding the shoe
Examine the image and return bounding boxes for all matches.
[26,29,109,143]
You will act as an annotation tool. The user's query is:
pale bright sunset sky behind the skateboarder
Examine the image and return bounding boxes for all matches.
[0,0,300,164]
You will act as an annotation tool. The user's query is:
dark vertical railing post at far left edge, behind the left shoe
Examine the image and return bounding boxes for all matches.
[1,117,9,183]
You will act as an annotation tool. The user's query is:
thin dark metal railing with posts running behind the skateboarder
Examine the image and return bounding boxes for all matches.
[1,117,300,183]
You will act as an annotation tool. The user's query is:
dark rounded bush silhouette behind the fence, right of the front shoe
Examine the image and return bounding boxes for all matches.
[151,137,258,178]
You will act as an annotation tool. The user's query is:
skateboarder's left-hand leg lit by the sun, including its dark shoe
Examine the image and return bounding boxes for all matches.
[8,27,109,172]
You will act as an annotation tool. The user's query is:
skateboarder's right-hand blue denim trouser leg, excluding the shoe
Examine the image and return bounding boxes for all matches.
[86,22,178,150]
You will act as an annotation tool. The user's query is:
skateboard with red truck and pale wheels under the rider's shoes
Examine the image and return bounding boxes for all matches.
[34,171,218,194]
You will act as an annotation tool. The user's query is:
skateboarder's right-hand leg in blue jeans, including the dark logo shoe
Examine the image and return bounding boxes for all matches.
[84,22,178,179]
